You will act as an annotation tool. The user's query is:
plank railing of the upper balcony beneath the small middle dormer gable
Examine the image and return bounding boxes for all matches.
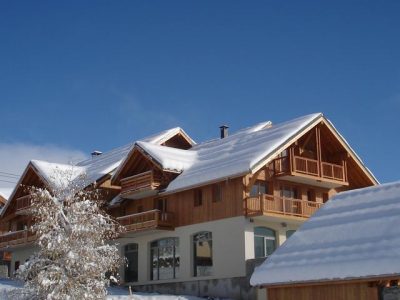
[121,171,161,195]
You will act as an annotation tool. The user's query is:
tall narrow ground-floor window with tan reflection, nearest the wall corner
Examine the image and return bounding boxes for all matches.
[193,231,213,276]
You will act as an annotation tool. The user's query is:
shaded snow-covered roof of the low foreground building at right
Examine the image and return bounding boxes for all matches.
[250,182,400,286]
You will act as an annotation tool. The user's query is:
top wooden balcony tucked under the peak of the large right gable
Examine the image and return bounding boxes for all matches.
[271,151,348,187]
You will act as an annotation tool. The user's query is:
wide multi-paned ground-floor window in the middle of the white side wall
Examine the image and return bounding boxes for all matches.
[150,238,180,280]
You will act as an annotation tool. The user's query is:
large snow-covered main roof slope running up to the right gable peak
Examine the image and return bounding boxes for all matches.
[166,113,322,193]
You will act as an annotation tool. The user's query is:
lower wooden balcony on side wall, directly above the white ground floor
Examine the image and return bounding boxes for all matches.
[117,209,174,232]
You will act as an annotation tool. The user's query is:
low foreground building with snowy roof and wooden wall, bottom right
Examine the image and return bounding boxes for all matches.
[251,182,400,300]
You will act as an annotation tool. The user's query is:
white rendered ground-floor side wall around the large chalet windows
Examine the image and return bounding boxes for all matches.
[116,217,248,285]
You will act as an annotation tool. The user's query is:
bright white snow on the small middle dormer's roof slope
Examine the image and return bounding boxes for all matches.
[136,142,197,172]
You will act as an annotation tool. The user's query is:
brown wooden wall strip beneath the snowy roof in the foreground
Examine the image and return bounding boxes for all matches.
[267,282,378,300]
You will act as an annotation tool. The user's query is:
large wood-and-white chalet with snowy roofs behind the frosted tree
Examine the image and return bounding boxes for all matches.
[0,114,378,299]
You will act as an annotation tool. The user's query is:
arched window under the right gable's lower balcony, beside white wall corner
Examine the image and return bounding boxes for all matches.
[254,227,276,258]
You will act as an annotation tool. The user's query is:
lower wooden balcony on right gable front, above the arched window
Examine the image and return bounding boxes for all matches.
[245,194,322,218]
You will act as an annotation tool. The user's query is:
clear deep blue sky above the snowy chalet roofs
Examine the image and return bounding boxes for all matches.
[0,1,400,187]
